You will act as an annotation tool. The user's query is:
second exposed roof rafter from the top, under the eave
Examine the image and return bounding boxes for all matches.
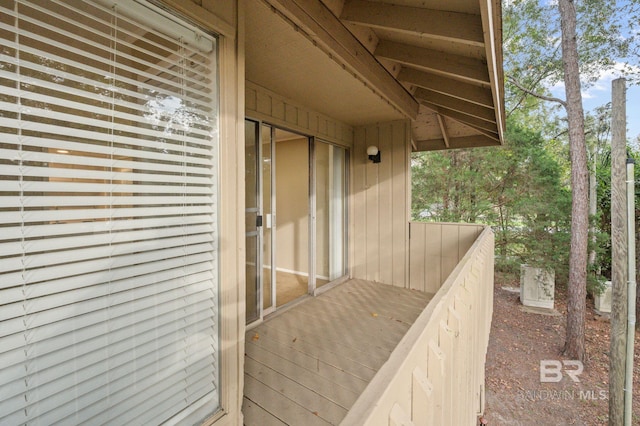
[374,40,490,87]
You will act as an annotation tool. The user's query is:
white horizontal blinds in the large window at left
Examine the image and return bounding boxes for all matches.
[0,0,219,425]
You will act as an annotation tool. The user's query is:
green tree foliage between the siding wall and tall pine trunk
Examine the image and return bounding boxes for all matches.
[412,120,571,283]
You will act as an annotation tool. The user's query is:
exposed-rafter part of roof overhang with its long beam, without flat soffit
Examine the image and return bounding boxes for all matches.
[248,0,504,151]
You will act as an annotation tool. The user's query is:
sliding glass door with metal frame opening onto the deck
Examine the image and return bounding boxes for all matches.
[245,120,348,323]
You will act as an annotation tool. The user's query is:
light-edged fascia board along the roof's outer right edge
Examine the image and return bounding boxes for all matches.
[480,0,505,141]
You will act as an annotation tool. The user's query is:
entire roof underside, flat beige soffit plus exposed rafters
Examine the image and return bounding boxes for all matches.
[245,0,504,151]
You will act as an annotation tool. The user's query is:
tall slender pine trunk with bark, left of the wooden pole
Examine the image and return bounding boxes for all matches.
[558,0,589,361]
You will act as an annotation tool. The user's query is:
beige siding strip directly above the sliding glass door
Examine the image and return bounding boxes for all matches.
[245,81,354,148]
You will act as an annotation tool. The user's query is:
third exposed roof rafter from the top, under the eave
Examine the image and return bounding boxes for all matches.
[397,67,493,108]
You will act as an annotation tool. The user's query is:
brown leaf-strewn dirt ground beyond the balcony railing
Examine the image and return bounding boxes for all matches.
[484,273,640,425]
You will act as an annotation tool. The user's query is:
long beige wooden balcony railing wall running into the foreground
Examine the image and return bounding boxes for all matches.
[341,228,494,426]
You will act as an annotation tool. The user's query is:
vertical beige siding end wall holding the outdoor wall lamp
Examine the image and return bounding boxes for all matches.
[351,121,410,287]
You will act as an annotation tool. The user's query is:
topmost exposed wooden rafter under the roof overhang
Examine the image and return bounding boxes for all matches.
[340,0,484,47]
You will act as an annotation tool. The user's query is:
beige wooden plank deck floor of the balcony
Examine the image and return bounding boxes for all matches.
[242,280,433,426]
